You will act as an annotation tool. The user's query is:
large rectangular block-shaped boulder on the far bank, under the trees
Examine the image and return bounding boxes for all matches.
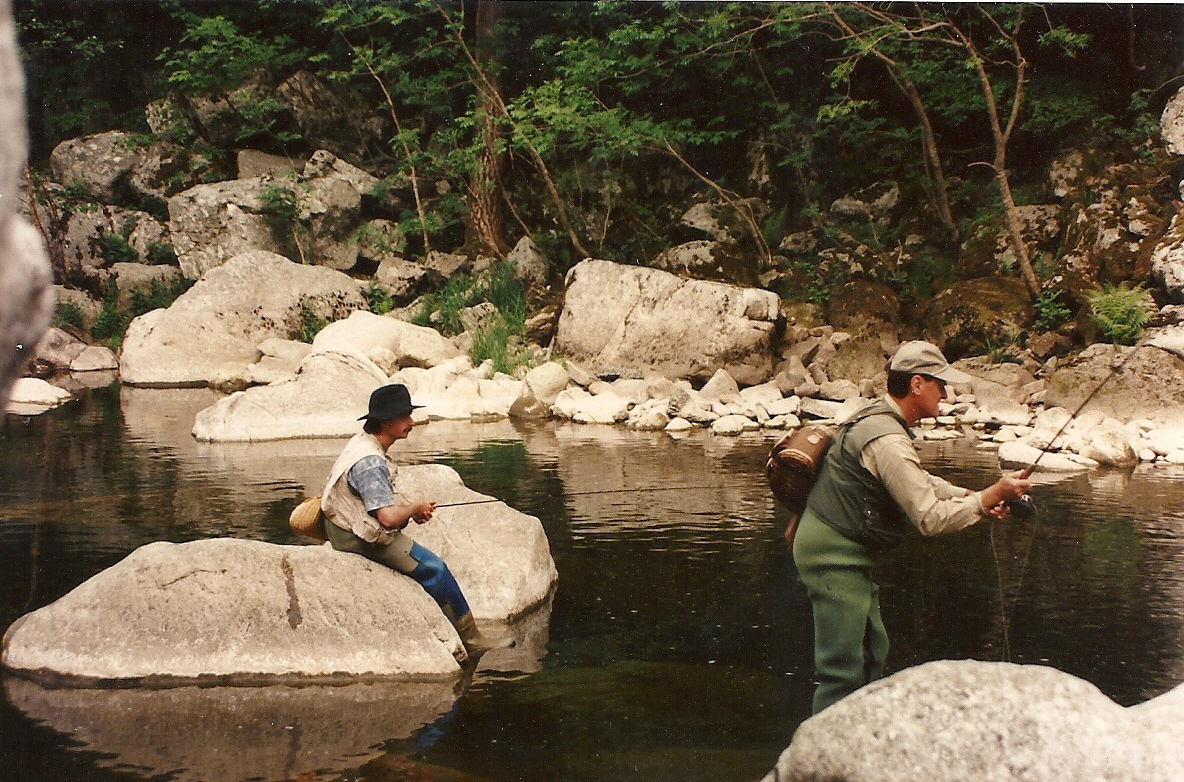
[552,259,780,385]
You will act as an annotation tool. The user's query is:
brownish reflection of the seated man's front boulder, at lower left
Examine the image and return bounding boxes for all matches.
[5,678,461,782]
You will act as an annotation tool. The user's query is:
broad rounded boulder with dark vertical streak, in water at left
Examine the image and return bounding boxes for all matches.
[2,539,461,684]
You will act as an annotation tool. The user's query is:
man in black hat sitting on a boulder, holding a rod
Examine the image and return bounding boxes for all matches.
[321,384,510,656]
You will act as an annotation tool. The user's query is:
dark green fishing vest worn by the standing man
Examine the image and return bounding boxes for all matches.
[806,399,913,550]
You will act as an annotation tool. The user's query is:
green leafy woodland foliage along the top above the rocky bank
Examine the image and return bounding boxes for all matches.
[14,0,1178,290]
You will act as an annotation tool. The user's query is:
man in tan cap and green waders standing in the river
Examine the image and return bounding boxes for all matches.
[793,341,1031,713]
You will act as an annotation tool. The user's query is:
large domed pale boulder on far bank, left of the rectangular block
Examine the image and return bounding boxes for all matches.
[120,251,366,387]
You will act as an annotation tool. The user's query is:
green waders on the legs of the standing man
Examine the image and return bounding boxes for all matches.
[793,509,888,714]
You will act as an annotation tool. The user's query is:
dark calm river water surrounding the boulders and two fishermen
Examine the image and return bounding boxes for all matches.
[0,386,1184,782]
